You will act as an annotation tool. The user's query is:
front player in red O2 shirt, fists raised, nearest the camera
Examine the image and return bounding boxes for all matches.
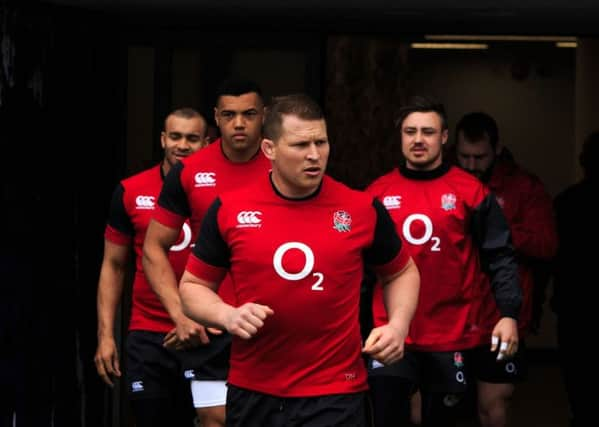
[180,95,419,427]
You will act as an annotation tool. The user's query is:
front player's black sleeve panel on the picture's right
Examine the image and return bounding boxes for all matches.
[364,199,401,265]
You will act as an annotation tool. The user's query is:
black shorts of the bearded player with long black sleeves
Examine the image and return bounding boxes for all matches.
[368,350,471,393]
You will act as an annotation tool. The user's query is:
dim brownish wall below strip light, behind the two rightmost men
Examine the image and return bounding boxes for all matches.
[408,44,575,195]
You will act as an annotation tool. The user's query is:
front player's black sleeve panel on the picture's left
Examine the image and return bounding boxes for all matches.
[193,197,231,268]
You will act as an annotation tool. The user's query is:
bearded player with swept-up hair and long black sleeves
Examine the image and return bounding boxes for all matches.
[366,96,521,427]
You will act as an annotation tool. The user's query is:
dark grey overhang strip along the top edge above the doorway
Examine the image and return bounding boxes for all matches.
[41,0,599,36]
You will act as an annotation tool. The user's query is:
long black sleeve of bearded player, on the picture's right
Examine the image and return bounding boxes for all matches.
[471,194,522,319]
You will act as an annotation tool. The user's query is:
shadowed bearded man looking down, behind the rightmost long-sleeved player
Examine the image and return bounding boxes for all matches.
[455,112,557,427]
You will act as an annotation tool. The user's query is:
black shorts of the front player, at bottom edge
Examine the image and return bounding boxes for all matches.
[226,384,370,427]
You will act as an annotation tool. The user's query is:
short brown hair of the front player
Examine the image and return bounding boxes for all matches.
[262,93,324,141]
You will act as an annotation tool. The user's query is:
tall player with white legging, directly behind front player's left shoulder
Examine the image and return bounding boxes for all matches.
[143,80,270,427]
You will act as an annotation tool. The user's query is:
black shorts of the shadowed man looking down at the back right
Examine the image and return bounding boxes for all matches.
[471,340,528,384]
